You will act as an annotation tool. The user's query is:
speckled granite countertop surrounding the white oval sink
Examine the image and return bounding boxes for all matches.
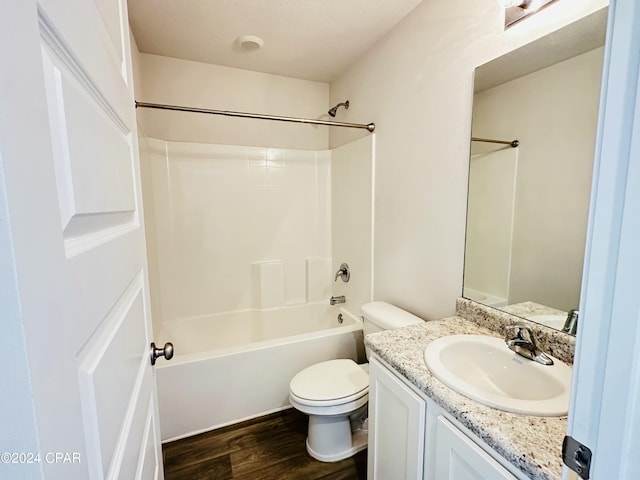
[365,316,567,480]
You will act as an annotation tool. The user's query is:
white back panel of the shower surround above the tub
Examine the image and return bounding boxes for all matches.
[144,139,331,321]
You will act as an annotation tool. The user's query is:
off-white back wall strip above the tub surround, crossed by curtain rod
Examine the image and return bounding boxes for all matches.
[136,53,329,150]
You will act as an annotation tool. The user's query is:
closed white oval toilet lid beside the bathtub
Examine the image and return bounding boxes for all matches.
[289,359,369,401]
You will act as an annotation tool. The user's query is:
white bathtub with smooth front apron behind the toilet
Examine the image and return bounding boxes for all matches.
[156,303,364,442]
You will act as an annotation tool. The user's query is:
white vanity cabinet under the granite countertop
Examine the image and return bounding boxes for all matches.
[367,355,527,480]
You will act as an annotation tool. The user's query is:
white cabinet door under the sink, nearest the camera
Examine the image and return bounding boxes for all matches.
[435,416,516,480]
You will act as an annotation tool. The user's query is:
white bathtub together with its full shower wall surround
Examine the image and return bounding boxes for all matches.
[144,138,373,441]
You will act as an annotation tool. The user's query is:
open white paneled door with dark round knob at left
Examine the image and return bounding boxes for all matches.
[0,0,163,480]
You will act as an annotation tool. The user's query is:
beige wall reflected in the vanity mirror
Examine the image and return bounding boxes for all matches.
[473,48,603,311]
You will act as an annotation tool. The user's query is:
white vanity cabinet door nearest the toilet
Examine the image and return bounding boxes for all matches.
[367,358,426,480]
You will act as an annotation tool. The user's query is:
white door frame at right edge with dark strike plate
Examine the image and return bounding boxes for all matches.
[565,0,640,480]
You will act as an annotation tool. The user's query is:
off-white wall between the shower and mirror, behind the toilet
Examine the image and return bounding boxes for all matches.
[330,0,608,318]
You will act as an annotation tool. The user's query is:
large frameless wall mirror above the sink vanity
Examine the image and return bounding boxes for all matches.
[463,8,607,330]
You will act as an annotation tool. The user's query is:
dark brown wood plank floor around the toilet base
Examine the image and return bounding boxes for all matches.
[162,409,367,480]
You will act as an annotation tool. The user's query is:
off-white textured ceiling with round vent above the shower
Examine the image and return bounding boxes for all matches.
[128,0,422,82]
